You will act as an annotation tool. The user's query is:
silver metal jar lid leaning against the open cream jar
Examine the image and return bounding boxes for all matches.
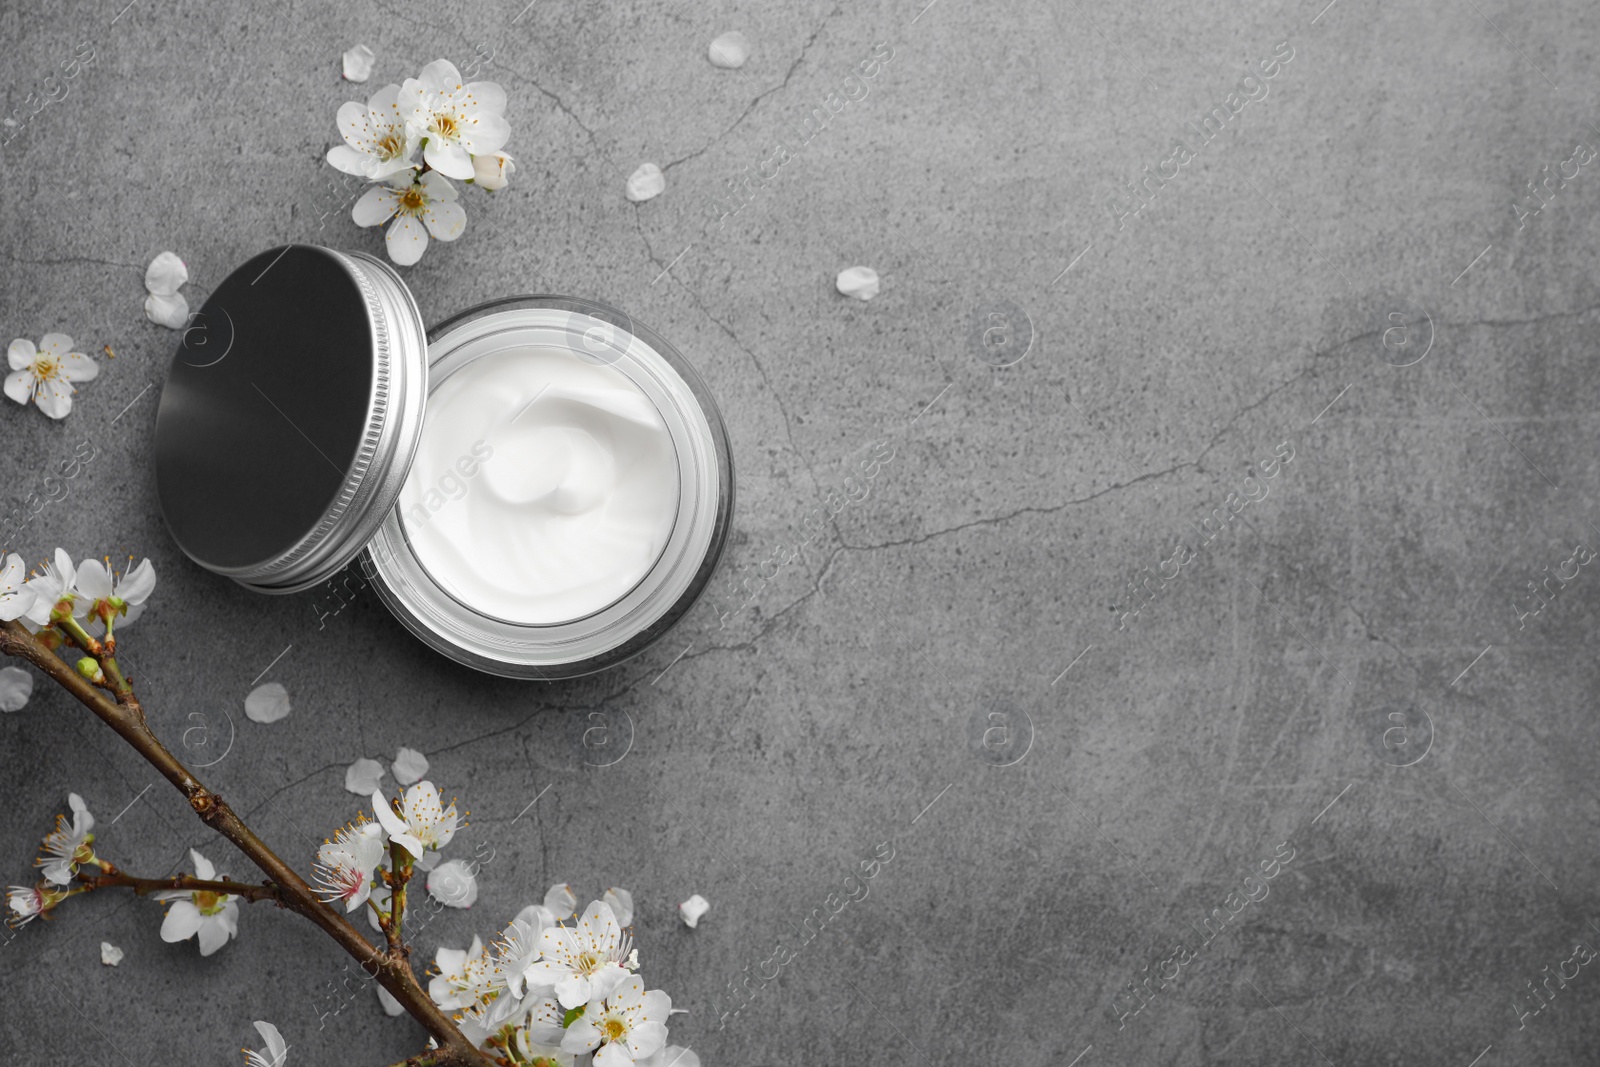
[155,245,427,593]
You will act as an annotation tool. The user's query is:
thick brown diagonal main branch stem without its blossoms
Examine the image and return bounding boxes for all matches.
[0,621,494,1067]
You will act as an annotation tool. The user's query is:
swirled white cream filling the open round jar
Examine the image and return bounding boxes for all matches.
[397,344,678,625]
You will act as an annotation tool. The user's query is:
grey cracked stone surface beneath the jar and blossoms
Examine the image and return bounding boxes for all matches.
[0,0,1600,1067]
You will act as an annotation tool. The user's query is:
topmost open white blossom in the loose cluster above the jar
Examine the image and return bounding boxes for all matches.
[400,59,510,181]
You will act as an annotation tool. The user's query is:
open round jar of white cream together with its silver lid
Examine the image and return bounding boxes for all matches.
[155,245,733,678]
